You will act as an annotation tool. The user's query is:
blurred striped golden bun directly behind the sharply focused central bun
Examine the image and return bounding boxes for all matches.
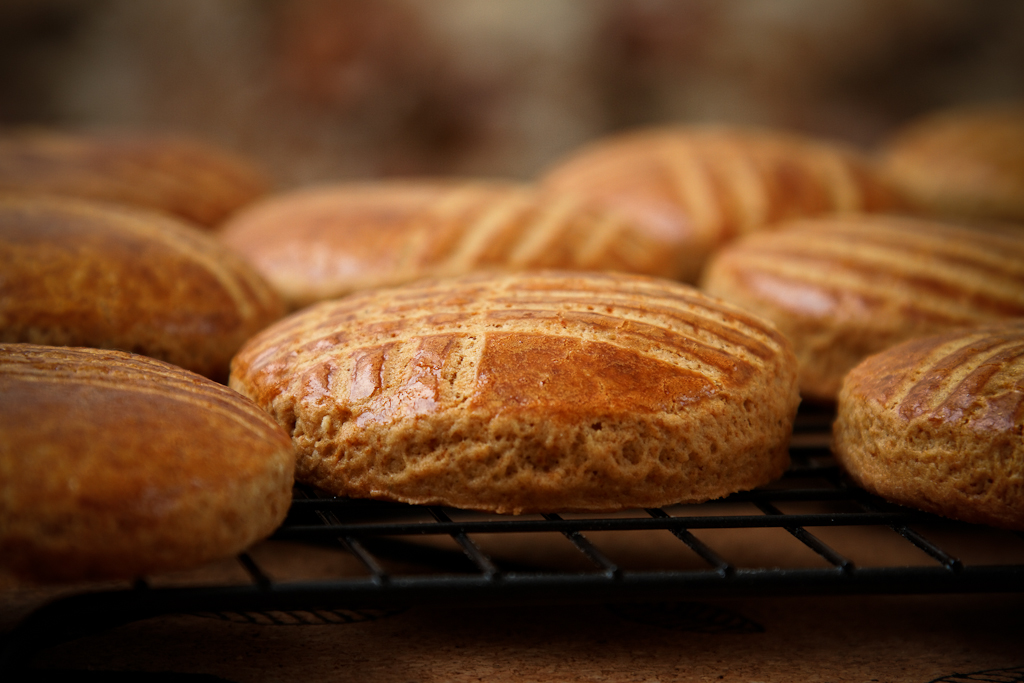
[220,179,692,308]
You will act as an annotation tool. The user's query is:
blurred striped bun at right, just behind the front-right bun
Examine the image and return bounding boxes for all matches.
[702,215,1024,401]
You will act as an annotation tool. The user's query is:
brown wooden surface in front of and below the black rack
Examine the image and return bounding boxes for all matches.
[2,596,1024,682]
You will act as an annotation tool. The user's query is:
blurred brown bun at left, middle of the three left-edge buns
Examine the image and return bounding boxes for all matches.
[0,197,284,380]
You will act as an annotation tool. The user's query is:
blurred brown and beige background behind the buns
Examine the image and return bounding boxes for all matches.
[0,0,1024,187]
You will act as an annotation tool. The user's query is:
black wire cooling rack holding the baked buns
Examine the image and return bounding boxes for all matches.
[0,410,1024,670]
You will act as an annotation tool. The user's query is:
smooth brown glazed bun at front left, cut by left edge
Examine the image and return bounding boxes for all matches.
[0,344,295,582]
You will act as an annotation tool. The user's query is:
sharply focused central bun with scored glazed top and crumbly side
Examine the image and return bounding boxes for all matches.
[230,271,799,513]
